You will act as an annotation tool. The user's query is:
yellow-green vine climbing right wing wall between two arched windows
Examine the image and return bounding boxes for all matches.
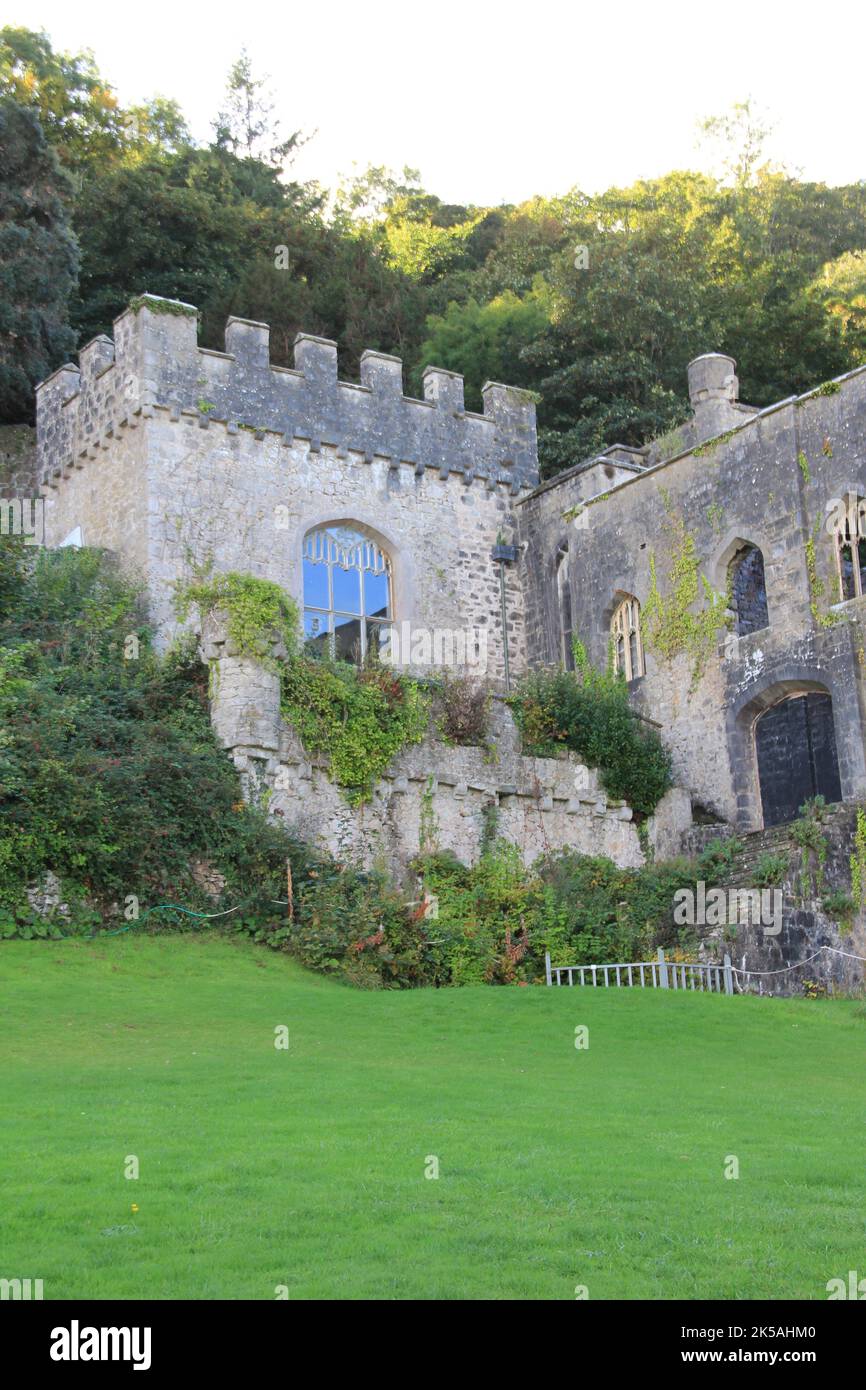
[642,506,730,689]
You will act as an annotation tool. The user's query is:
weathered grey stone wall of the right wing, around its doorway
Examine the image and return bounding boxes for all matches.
[517,359,866,828]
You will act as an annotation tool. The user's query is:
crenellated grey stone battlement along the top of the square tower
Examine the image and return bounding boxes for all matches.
[36,295,538,493]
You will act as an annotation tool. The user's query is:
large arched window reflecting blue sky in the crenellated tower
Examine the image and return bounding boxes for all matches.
[303,523,392,663]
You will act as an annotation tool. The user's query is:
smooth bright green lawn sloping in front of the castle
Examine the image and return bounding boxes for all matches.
[0,935,866,1300]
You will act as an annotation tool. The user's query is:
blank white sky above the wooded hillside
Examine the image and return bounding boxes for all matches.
[3,0,866,203]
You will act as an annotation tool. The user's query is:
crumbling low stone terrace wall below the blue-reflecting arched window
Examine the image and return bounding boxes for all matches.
[203,624,691,874]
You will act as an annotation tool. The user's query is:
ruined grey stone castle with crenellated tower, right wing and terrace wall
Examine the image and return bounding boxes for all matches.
[38,295,866,934]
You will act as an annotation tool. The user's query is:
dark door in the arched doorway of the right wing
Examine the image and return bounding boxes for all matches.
[755,691,842,826]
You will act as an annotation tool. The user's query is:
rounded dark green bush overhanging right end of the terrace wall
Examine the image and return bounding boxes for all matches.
[509,644,671,816]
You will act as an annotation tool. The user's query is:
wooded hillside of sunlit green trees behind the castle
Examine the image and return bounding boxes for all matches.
[0,28,866,475]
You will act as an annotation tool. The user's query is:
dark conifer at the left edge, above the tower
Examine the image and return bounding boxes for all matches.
[0,99,78,421]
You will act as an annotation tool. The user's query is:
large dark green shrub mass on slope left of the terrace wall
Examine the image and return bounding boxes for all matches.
[0,543,302,930]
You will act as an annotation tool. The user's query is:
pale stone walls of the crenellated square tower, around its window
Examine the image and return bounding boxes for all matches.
[38,296,537,680]
